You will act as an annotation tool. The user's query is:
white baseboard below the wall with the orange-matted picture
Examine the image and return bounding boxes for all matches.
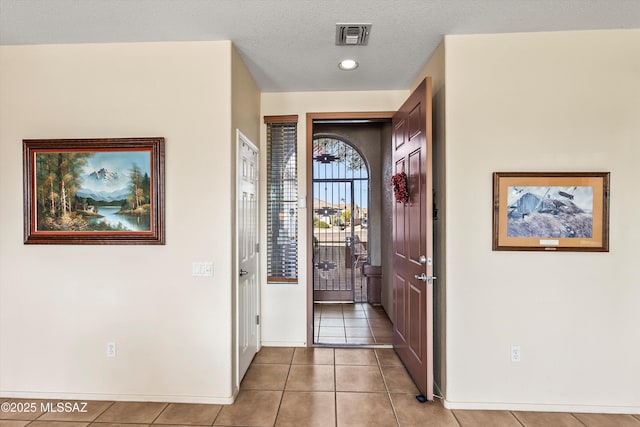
[443,399,640,414]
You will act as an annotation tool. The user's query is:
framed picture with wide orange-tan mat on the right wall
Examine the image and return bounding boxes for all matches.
[493,172,609,252]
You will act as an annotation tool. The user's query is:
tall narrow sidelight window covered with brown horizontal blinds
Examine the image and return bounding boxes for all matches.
[264,116,298,283]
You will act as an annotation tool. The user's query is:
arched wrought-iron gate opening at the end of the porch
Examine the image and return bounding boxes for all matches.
[313,136,369,302]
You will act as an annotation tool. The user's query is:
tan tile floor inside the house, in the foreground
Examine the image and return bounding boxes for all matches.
[0,347,640,427]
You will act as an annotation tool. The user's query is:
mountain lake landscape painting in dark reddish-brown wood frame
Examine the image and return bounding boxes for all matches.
[22,138,165,245]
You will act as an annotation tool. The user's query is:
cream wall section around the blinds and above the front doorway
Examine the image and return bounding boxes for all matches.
[260,90,409,346]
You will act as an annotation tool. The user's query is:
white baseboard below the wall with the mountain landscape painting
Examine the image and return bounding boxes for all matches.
[0,390,235,405]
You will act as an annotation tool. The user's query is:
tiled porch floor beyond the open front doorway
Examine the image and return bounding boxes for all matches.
[313,303,393,345]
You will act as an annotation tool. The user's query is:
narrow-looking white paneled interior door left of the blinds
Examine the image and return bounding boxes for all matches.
[236,130,260,386]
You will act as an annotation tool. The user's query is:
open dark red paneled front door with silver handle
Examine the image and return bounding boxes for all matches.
[392,77,433,400]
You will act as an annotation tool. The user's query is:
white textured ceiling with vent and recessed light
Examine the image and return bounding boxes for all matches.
[0,0,640,92]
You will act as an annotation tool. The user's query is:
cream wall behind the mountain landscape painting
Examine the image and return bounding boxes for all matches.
[0,42,240,403]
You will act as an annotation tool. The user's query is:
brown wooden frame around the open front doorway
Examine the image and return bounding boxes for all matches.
[305,111,395,347]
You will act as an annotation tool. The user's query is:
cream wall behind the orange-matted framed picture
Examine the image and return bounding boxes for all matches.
[445,30,640,413]
